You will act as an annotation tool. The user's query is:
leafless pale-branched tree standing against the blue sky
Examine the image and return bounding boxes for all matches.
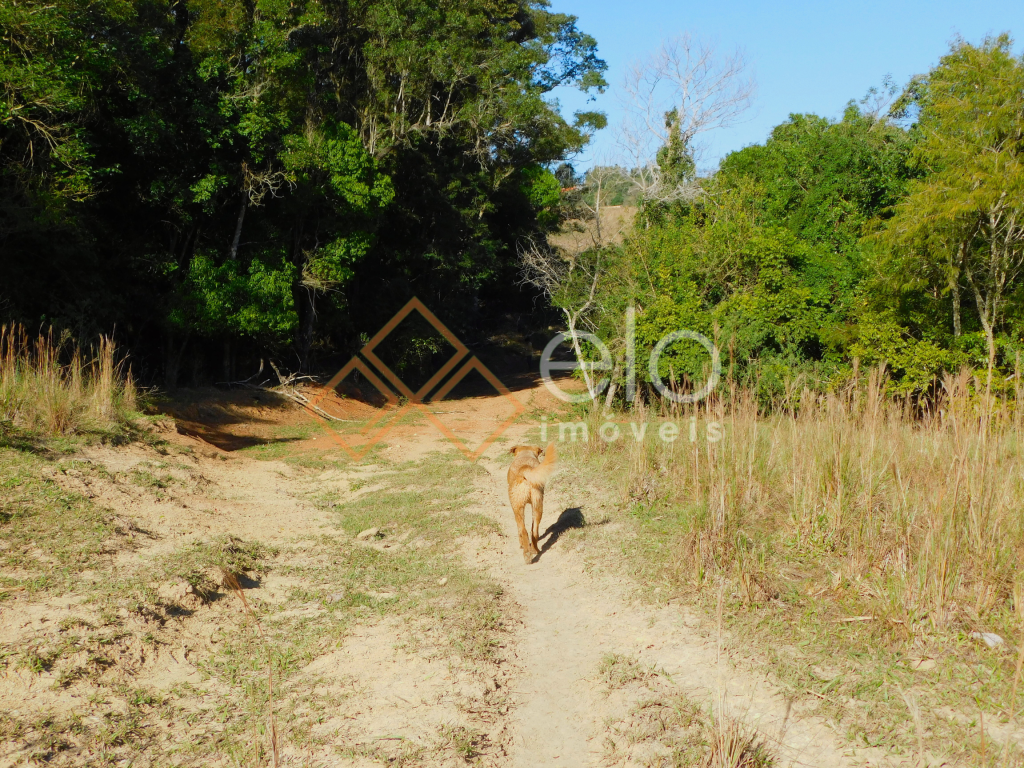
[620,33,755,202]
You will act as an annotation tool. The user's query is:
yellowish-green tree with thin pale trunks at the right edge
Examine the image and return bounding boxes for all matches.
[885,35,1024,385]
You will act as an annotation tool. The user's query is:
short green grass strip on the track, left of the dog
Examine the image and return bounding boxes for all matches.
[154,452,506,765]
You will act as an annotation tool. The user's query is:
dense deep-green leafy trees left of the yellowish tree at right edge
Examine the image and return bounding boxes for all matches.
[592,94,925,397]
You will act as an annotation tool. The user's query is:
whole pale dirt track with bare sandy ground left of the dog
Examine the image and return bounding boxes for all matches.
[0,390,905,768]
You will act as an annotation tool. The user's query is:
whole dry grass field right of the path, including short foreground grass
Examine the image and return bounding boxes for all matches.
[567,371,1024,765]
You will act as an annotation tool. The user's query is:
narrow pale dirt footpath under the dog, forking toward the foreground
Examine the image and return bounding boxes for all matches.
[462,434,882,768]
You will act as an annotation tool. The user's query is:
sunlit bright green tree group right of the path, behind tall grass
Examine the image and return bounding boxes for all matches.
[553,36,1024,398]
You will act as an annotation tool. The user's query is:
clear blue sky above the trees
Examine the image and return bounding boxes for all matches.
[551,0,1024,170]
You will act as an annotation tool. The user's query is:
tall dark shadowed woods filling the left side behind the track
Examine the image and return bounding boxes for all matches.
[0,0,605,386]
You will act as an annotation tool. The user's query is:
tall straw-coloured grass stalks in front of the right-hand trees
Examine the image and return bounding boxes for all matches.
[589,371,1024,636]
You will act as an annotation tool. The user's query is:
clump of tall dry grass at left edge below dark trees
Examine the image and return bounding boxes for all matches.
[0,326,138,436]
